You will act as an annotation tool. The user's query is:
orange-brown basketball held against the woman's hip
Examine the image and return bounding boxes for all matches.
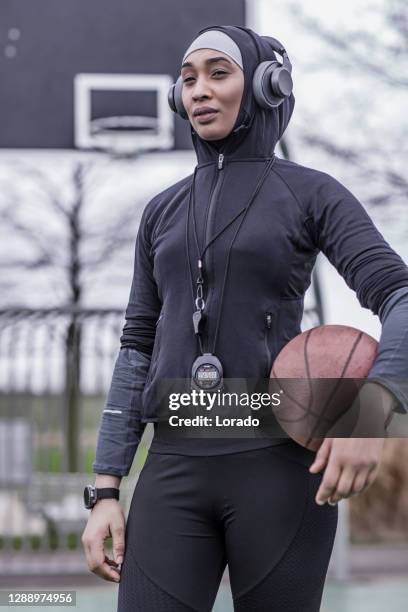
[270,325,378,451]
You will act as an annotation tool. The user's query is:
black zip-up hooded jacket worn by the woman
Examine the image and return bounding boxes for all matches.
[94,26,408,474]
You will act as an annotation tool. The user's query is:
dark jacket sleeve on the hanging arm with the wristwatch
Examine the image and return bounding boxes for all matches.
[92,207,161,476]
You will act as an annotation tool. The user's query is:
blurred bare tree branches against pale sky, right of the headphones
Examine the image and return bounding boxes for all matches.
[287,0,408,221]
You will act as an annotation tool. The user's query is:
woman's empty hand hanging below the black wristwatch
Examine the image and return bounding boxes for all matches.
[82,499,125,582]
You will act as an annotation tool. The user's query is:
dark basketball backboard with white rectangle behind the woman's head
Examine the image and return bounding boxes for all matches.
[0,0,245,149]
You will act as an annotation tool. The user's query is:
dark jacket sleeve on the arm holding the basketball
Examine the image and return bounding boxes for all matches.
[305,173,408,412]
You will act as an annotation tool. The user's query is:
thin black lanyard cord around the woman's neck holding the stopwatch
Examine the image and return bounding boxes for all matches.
[186,154,275,354]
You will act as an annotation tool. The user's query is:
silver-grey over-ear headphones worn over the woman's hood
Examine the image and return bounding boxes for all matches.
[167,36,293,120]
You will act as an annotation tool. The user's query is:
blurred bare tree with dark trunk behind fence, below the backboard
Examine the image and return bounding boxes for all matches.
[0,161,150,471]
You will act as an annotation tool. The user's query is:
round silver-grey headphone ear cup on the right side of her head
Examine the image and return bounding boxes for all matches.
[252,60,293,109]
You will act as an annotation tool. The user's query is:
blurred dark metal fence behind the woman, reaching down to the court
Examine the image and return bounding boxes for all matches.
[0,307,348,577]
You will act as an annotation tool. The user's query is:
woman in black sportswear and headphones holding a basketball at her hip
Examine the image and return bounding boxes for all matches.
[83,26,408,612]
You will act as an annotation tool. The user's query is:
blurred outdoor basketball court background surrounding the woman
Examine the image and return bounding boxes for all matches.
[0,0,408,612]
